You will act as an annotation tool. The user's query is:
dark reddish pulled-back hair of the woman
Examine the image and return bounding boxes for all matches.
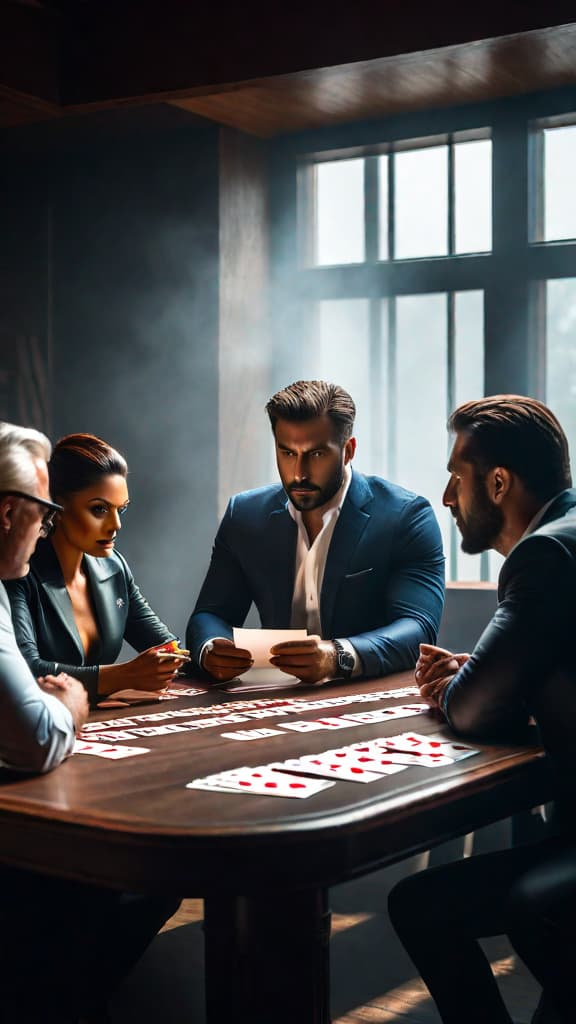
[48,434,128,498]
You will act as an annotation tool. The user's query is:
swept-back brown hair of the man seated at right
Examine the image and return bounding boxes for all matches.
[448,394,572,502]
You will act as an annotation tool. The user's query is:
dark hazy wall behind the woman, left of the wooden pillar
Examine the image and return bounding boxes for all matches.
[0,108,218,633]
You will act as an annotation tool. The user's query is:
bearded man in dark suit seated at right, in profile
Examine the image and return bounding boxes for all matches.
[389,395,576,1024]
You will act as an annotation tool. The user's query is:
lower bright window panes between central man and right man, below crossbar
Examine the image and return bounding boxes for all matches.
[303,292,486,580]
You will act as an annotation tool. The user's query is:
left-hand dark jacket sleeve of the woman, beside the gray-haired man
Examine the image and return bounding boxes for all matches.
[4,574,98,697]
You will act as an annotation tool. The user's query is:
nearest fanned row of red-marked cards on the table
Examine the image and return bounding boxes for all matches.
[188,732,479,800]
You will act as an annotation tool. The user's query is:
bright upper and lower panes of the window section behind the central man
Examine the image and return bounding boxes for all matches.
[294,132,492,579]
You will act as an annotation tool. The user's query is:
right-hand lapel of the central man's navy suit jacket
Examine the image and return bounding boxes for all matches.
[320,471,373,638]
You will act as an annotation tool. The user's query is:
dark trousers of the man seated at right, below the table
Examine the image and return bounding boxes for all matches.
[388,839,576,1024]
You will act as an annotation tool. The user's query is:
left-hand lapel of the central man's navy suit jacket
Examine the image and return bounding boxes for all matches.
[262,500,298,627]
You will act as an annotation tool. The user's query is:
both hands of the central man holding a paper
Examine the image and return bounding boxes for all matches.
[202,636,337,684]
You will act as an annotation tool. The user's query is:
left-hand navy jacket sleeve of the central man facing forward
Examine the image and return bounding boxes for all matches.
[186,498,252,668]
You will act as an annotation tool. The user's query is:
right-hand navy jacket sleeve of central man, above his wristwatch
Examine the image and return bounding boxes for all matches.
[347,497,444,676]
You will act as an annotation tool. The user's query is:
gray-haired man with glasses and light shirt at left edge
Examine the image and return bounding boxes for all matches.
[0,423,177,1024]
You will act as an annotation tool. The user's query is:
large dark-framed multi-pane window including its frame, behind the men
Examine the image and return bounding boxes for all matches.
[275,97,576,580]
